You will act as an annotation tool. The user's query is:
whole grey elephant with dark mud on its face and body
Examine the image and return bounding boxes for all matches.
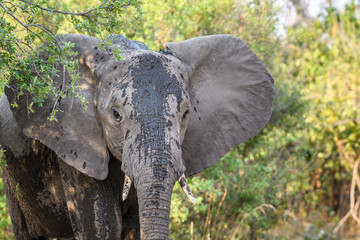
[0,34,275,239]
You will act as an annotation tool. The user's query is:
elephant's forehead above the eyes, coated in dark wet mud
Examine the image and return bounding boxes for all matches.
[120,53,186,114]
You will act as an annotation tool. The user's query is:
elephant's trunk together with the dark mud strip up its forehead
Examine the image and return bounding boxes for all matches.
[119,68,185,239]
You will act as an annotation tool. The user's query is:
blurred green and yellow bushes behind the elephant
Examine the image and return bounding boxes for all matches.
[0,0,360,239]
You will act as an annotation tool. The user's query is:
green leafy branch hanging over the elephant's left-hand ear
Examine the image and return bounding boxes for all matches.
[0,0,142,120]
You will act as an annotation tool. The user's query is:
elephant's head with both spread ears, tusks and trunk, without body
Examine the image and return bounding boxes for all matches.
[6,35,275,239]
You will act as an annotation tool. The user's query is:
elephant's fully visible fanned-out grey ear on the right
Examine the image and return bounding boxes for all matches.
[166,35,275,176]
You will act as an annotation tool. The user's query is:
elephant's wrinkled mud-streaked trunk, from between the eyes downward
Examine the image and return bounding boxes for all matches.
[122,115,185,239]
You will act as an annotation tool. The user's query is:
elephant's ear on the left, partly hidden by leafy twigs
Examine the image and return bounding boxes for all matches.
[5,34,111,179]
